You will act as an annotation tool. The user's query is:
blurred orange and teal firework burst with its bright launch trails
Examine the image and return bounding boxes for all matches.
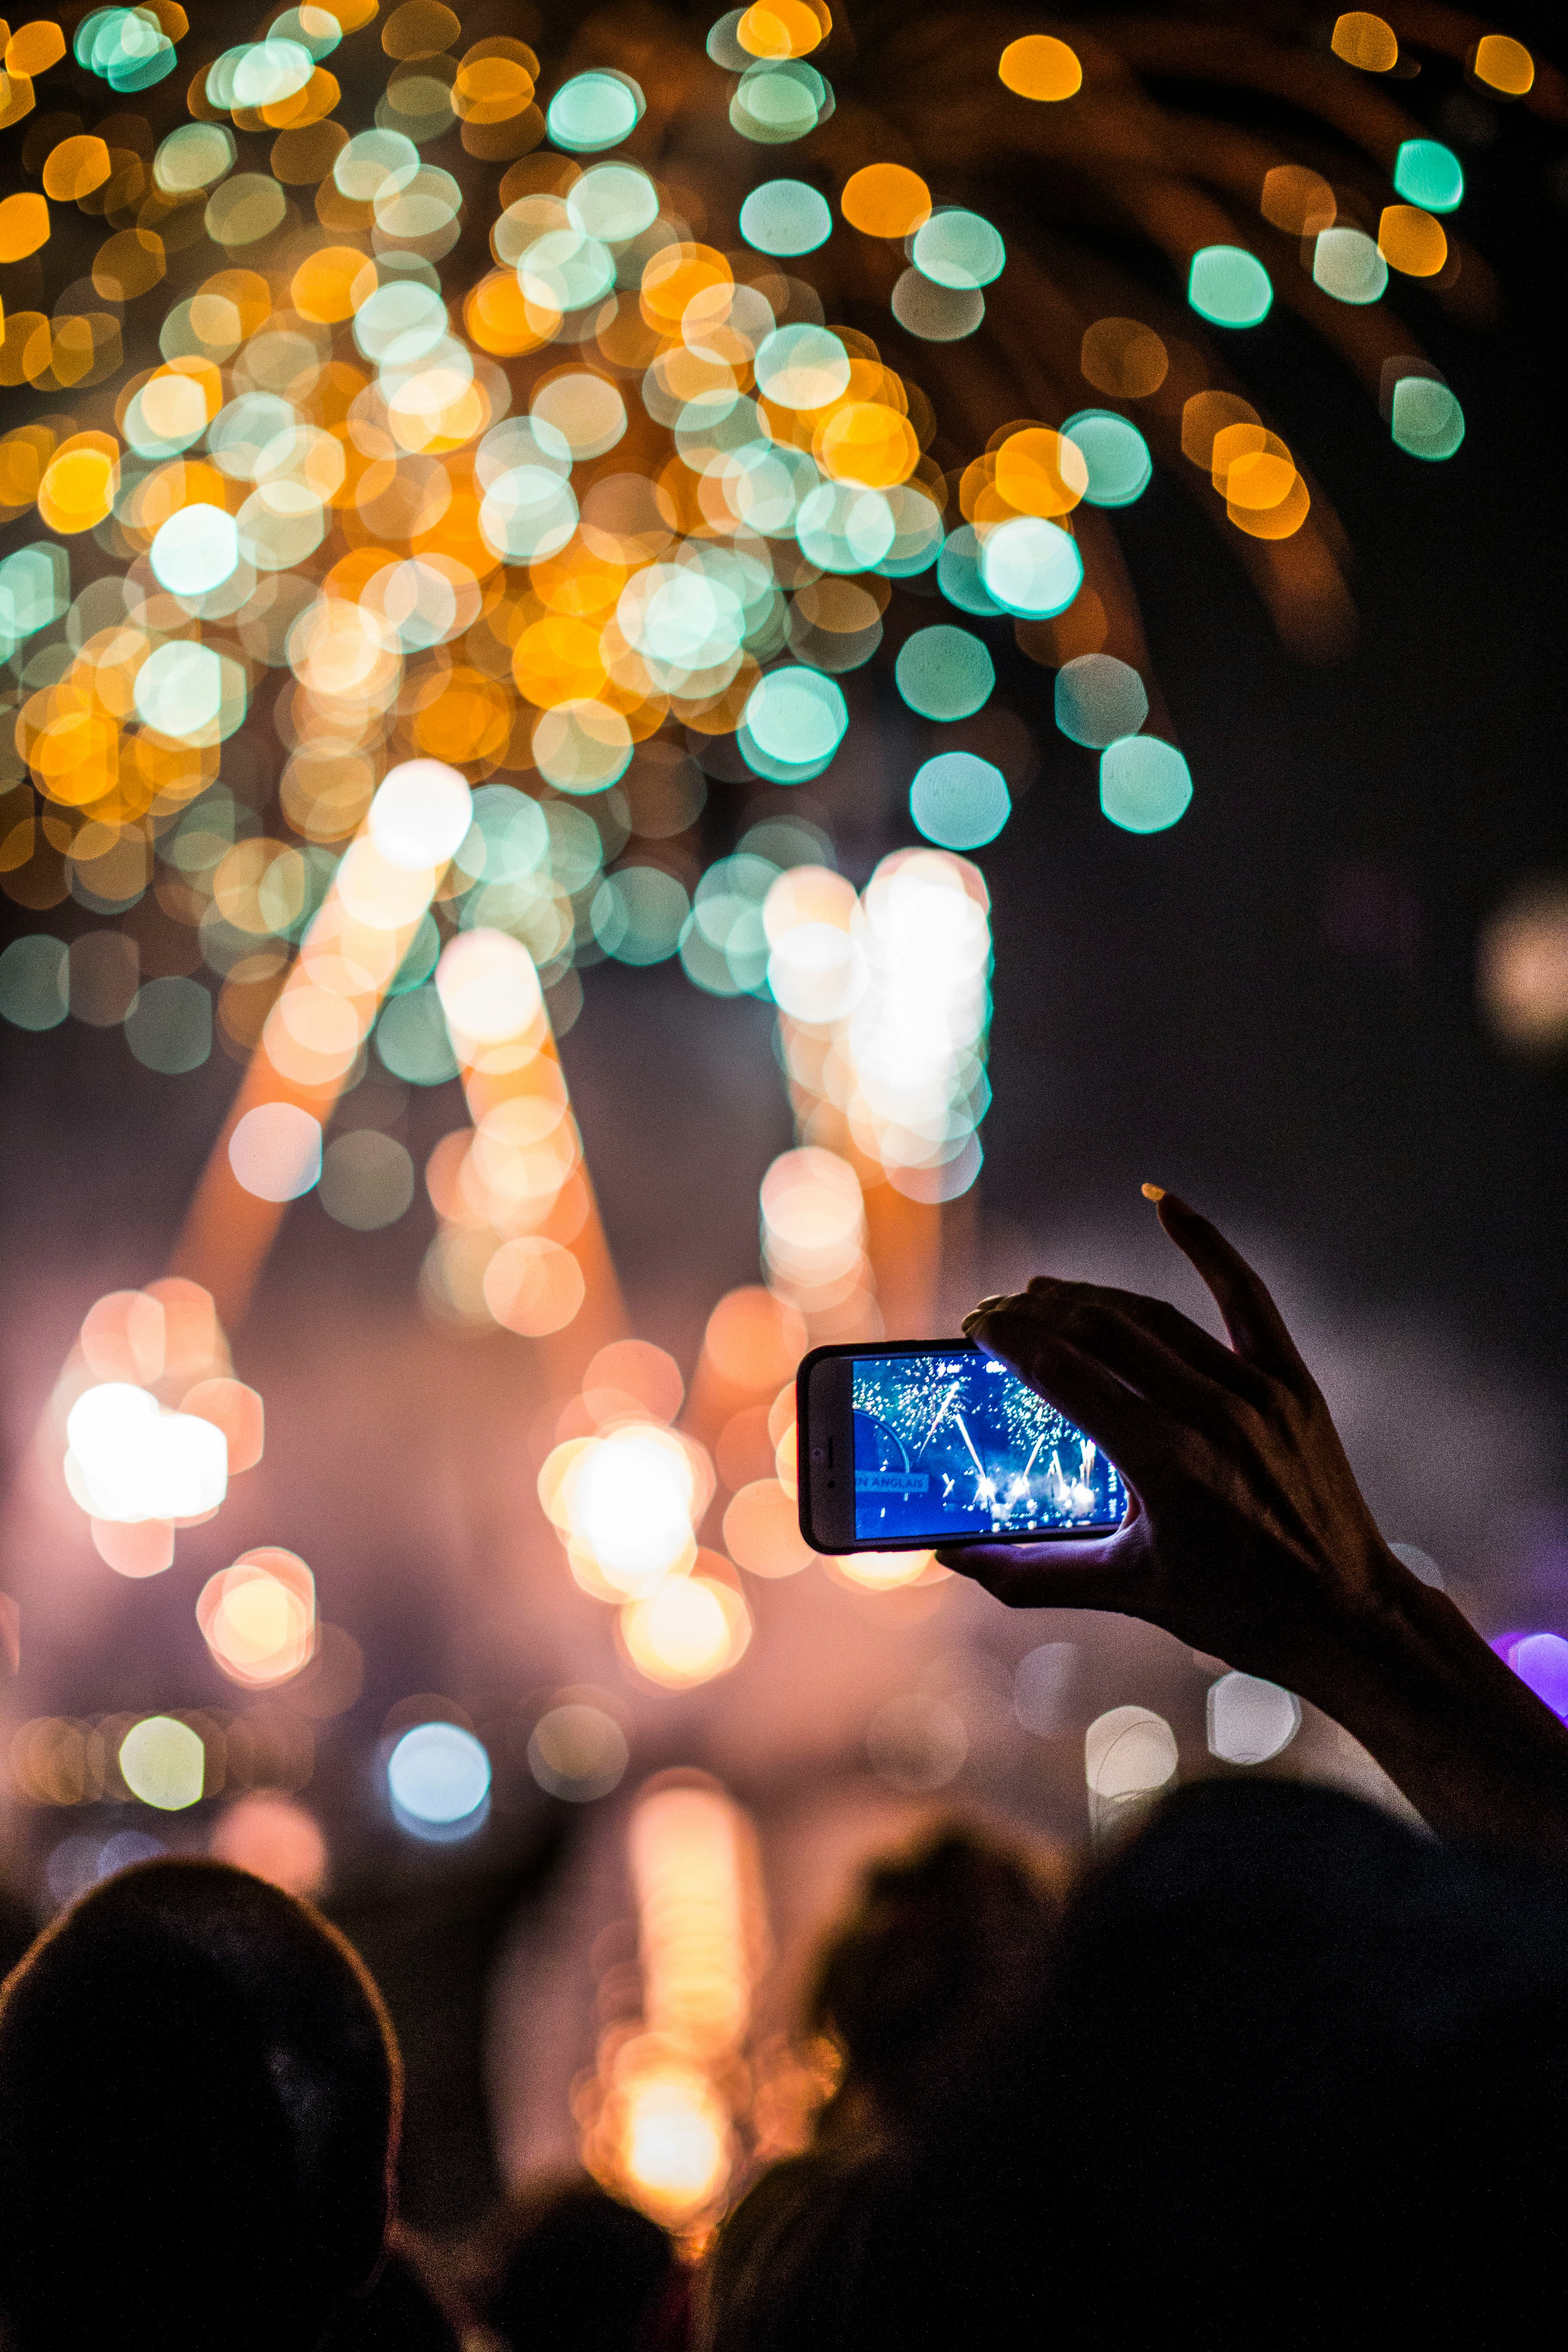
[0,0,1568,1599]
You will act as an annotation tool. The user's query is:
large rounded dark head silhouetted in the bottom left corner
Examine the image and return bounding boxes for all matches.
[0,1860,400,2352]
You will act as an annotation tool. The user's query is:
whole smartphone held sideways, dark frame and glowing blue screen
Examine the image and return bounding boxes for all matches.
[795,1338,1126,1553]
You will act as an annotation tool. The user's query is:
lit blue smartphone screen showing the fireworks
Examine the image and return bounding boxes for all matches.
[851,1348,1126,1545]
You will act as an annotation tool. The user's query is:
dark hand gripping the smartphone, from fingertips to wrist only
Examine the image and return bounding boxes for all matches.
[938,1188,1420,1698]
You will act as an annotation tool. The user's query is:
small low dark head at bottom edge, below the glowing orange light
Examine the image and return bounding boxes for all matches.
[468,2173,684,2352]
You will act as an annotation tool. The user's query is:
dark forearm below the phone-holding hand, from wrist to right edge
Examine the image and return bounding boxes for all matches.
[1302,1578,1568,1863]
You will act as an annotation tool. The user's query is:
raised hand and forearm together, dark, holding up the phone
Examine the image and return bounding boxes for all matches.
[938,1185,1568,1856]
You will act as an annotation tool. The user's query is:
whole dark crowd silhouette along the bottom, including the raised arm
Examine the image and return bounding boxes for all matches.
[0,1195,1568,2352]
